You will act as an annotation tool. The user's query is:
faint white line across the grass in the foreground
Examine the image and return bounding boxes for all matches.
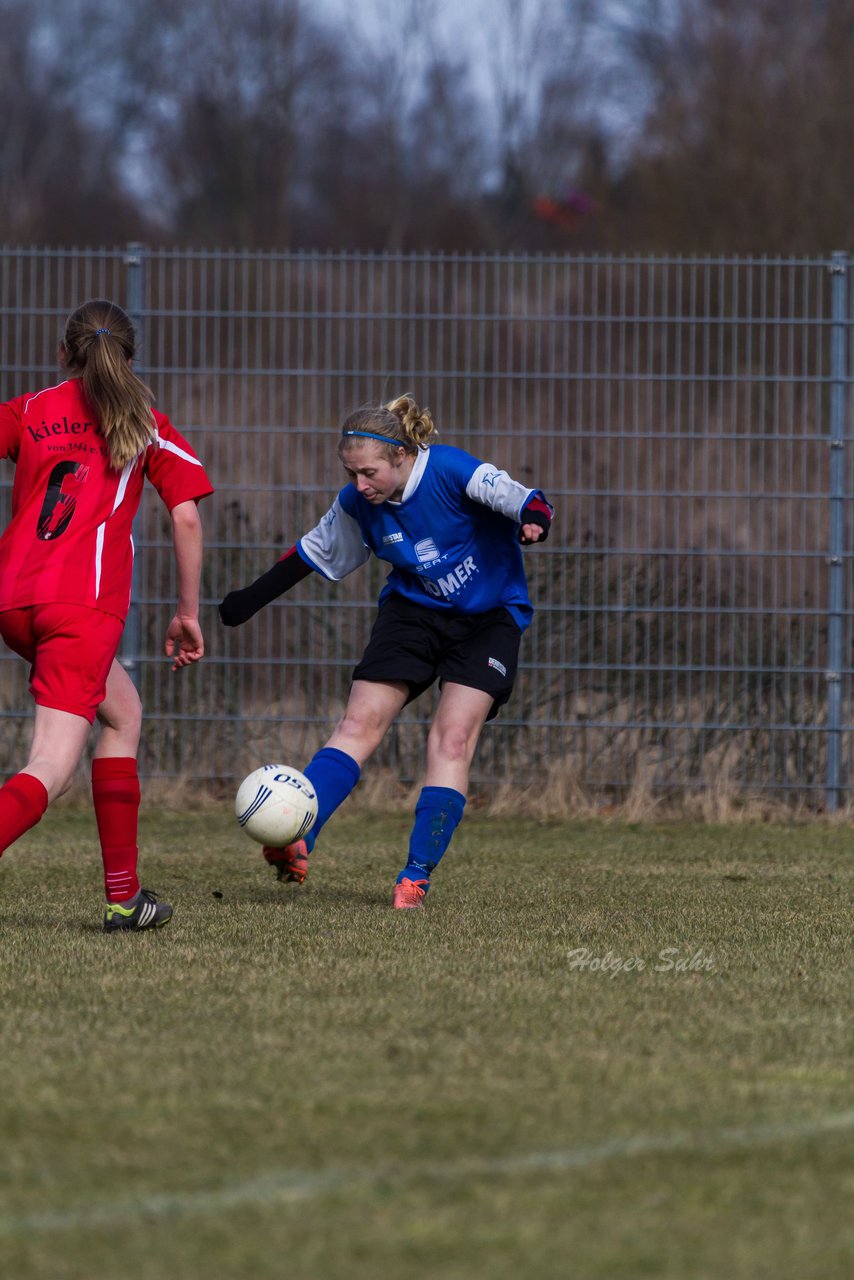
[0,1111,854,1238]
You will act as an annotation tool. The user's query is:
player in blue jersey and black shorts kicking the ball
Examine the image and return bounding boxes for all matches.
[219,396,552,908]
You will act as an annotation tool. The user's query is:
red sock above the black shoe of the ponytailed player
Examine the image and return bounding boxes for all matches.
[92,755,140,902]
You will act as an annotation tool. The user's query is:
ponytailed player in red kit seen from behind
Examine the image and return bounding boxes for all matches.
[0,301,213,933]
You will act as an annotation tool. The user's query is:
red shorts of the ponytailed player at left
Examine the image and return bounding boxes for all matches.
[0,604,124,724]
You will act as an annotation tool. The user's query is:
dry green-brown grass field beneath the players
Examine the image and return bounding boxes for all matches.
[0,809,854,1280]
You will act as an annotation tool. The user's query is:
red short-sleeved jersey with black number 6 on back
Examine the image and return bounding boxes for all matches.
[0,378,214,618]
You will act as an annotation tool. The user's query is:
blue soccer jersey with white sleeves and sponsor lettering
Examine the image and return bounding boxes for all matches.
[297,444,544,630]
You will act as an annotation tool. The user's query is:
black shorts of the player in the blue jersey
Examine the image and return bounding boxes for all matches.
[353,593,522,719]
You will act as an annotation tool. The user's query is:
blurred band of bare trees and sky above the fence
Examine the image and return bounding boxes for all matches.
[20,0,854,252]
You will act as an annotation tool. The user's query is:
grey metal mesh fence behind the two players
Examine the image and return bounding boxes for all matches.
[0,246,853,808]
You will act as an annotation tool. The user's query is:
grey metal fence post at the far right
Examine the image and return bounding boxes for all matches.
[825,250,848,813]
